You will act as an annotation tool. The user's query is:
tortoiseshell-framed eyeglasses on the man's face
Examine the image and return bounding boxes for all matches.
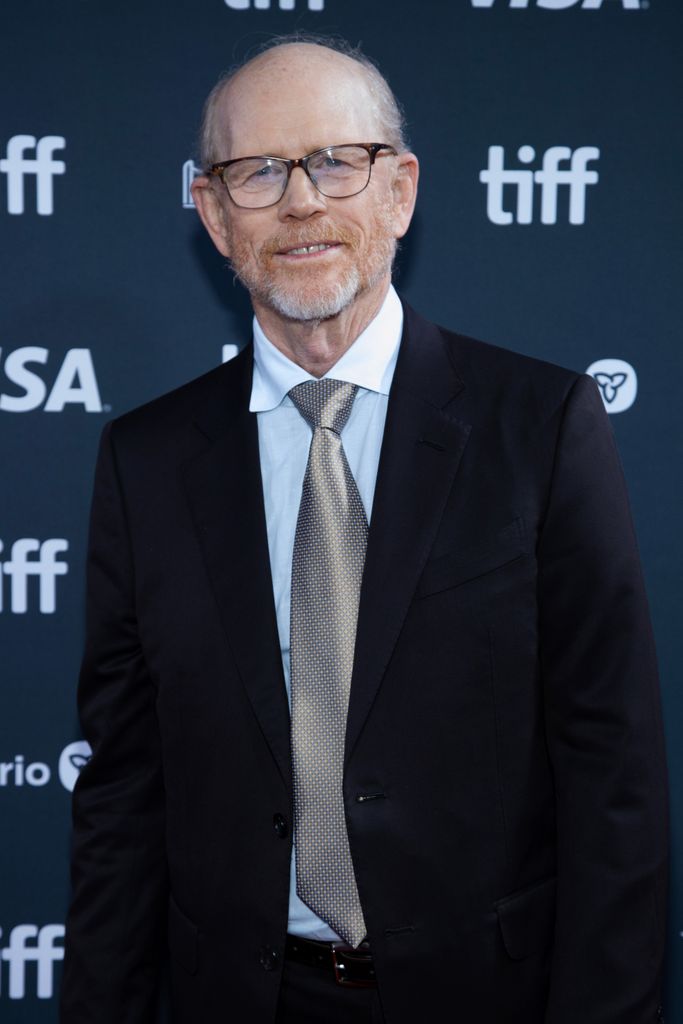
[207,142,396,210]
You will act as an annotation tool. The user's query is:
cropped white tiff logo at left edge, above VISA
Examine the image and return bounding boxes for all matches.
[0,135,67,217]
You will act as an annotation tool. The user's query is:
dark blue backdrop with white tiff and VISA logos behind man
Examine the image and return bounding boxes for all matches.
[0,0,683,1024]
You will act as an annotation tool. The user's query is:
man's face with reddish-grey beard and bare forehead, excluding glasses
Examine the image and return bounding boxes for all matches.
[192,46,412,321]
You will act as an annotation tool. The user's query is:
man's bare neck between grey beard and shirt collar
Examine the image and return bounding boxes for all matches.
[253,276,390,377]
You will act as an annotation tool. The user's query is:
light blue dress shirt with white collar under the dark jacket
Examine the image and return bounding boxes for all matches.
[249,286,403,942]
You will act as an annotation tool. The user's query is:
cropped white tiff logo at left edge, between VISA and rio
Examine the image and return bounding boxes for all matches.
[0,537,69,615]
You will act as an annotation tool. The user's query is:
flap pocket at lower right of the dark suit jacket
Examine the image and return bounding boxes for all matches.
[496,878,557,959]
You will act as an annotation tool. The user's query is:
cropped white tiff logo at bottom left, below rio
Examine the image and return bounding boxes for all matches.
[0,925,65,999]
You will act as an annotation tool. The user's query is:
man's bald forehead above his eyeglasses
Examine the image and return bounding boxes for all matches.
[211,43,377,159]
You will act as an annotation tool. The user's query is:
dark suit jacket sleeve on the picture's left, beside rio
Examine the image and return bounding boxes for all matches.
[60,425,168,1024]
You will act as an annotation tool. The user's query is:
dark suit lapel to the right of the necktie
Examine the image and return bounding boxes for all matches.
[346,307,470,759]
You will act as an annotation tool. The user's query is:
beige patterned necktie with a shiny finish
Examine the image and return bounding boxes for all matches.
[290,378,368,947]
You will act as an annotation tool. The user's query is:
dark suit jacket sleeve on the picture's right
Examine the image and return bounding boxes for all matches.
[539,377,667,1024]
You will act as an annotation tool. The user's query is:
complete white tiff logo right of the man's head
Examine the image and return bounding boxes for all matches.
[479,145,600,224]
